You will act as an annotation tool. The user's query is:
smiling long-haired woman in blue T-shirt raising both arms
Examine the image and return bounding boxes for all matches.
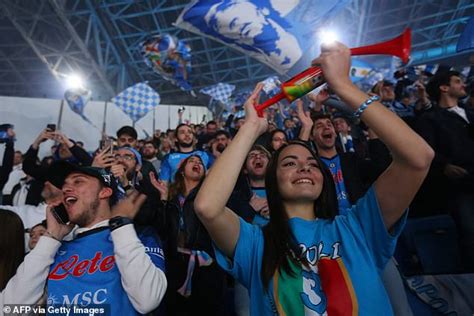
[195,43,433,315]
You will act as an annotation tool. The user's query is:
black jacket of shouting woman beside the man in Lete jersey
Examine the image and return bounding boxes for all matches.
[138,187,225,315]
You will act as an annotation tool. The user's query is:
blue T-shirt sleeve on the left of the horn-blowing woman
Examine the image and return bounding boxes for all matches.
[214,218,263,288]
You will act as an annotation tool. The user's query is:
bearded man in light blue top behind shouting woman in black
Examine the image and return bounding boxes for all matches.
[159,124,214,184]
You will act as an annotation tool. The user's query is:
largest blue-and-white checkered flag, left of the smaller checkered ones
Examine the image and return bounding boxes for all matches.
[112,82,161,122]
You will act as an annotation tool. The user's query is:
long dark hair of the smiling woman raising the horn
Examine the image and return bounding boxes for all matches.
[261,141,337,288]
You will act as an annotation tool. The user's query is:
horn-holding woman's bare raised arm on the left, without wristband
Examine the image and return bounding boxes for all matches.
[194,84,268,258]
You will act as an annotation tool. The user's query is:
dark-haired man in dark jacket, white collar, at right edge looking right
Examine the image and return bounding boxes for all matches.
[418,71,474,271]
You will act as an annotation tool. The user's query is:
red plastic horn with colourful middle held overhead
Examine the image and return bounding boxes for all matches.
[255,28,411,117]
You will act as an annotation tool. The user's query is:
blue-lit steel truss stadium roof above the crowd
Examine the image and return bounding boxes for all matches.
[0,0,474,104]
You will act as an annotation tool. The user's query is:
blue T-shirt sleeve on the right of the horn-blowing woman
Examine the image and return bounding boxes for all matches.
[347,186,408,272]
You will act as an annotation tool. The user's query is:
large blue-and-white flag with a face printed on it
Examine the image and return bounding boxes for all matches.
[176,0,350,73]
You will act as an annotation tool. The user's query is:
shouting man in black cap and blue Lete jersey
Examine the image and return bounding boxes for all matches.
[42,162,167,315]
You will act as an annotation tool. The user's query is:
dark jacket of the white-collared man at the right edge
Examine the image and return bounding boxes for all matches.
[410,107,474,217]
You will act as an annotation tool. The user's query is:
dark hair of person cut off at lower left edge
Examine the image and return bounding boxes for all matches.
[0,209,25,291]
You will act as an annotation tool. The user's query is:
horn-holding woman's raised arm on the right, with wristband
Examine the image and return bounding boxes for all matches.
[313,43,434,229]
